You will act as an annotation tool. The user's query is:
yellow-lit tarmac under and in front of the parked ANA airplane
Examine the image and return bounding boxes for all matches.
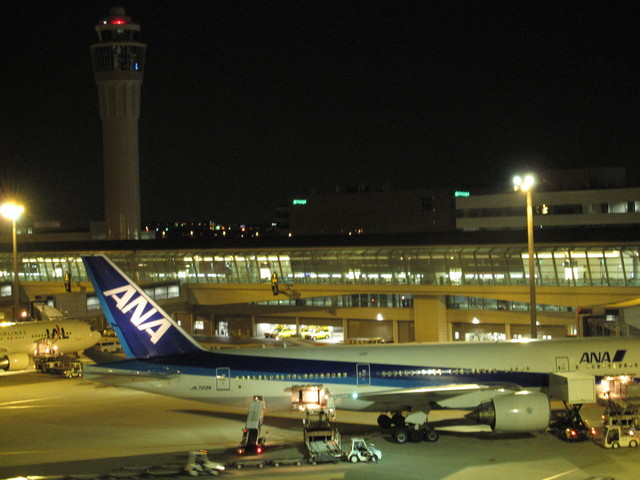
[0,366,640,480]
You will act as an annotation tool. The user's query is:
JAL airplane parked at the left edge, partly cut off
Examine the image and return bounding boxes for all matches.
[0,320,101,372]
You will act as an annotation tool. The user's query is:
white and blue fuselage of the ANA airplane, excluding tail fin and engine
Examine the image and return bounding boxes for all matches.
[85,338,640,410]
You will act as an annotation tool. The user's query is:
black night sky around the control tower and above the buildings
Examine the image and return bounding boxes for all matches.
[0,0,640,223]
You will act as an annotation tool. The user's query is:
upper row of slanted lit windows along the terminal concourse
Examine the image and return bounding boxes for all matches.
[0,246,640,286]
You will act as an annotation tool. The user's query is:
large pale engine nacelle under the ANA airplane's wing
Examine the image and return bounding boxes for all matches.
[468,391,551,433]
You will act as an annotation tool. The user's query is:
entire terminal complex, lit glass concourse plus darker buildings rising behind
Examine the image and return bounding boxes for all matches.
[0,169,640,342]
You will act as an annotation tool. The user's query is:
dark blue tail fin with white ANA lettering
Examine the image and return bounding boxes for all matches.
[82,255,202,358]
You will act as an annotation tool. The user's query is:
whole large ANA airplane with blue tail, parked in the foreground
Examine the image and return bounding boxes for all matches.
[83,256,640,438]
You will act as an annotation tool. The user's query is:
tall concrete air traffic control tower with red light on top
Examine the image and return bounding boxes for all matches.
[91,7,147,240]
